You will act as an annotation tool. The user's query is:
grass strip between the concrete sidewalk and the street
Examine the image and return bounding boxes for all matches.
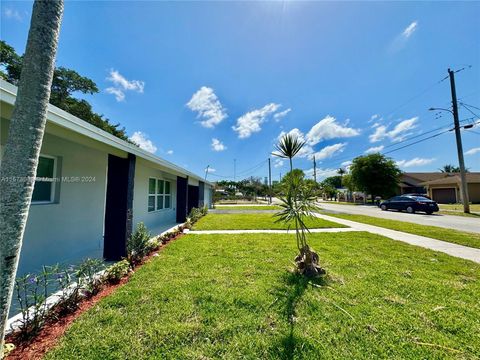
[323,212,480,249]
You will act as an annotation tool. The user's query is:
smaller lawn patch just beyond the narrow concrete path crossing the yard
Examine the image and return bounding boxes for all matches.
[193,213,346,230]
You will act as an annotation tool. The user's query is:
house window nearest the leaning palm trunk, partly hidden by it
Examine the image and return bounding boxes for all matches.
[32,155,56,203]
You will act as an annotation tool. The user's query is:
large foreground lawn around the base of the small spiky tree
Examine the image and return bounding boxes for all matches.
[45,232,480,360]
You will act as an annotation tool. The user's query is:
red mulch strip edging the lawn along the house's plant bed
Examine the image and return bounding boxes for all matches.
[5,234,183,360]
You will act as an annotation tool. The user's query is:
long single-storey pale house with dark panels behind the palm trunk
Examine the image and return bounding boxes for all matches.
[0,80,213,275]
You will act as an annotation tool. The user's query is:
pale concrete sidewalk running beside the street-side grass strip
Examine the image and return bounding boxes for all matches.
[315,214,480,264]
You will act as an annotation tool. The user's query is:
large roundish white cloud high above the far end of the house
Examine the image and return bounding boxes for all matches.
[187,86,227,128]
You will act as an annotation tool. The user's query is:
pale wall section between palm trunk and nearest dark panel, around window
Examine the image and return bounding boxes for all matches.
[1,120,107,275]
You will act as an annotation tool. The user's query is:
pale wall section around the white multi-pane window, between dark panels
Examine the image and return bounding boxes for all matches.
[133,158,177,235]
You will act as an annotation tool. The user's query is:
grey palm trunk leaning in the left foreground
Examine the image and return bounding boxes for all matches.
[0,0,63,358]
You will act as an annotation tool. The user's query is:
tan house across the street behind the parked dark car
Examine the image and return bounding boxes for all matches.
[398,172,480,204]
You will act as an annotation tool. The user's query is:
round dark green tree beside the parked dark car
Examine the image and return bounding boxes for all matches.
[350,153,401,202]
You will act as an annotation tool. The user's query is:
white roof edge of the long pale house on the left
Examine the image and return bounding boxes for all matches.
[0,79,213,186]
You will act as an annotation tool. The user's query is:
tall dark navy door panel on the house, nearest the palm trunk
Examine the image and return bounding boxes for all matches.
[103,155,135,260]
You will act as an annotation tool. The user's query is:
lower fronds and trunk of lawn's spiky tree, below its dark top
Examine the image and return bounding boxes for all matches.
[275,171,325,276]
